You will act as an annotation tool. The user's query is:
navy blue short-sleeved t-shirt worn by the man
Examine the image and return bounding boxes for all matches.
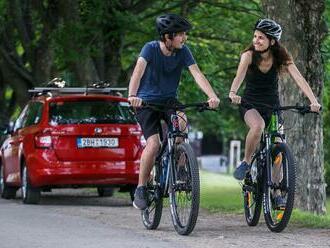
[137,41,196,101]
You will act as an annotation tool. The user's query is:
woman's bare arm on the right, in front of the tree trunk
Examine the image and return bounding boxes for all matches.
[287,63,321,112]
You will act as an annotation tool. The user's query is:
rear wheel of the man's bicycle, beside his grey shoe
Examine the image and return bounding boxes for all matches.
[141,162,163,230]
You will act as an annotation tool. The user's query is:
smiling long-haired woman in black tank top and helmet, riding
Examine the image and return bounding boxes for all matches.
[229,19,321,204]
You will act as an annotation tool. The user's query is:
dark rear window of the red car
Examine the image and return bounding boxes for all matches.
[49,100,136,125]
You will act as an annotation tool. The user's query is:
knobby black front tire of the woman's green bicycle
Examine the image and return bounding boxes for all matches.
[264,143,296,232]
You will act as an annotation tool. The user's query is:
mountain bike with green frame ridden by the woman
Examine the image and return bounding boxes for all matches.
[233,99,314,232]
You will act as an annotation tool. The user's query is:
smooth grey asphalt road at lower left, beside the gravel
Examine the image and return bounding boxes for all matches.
[0,192,180,248]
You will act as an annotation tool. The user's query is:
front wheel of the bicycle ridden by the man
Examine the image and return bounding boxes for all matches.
[169,143,200,235]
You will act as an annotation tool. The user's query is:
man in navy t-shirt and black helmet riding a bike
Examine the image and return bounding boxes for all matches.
[128,14,220,210]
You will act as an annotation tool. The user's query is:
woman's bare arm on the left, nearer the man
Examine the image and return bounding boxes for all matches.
[229,51,252,104]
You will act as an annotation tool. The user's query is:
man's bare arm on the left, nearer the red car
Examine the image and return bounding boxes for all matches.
[128,57,147,107]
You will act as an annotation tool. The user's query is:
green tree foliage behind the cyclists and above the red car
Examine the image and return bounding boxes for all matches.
[0,0,261,139]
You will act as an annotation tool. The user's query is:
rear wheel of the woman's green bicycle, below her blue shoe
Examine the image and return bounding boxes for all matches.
[242,159,262,226]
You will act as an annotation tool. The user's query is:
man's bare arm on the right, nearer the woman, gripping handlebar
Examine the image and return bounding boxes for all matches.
[188,64,220,108]
